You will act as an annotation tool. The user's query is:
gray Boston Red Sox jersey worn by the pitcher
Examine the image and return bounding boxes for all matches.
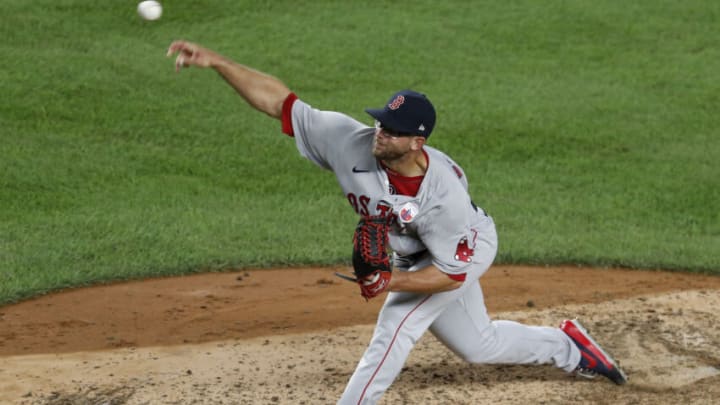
[291,100,492,274]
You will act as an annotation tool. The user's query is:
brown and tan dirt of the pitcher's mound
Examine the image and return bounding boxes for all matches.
[0,266,720,405]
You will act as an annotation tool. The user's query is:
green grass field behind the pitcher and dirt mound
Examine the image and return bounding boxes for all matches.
[0,0,720,303]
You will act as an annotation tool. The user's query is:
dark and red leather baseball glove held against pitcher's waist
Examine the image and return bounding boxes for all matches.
[336,216,392,299]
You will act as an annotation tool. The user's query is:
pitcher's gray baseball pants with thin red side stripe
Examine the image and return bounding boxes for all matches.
[338,218,580,404]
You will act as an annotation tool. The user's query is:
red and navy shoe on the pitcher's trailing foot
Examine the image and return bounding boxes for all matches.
[560,319,627,385]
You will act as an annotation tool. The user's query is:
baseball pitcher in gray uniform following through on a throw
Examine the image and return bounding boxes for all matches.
[168,41,626,404]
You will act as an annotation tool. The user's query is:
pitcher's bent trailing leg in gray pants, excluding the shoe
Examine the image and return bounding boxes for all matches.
[430,284,579,372]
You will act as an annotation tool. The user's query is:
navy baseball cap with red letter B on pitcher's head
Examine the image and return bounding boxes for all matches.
[365,90,435,138]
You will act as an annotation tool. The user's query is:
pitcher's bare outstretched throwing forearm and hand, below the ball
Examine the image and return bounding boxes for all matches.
[167,41,290,119]
